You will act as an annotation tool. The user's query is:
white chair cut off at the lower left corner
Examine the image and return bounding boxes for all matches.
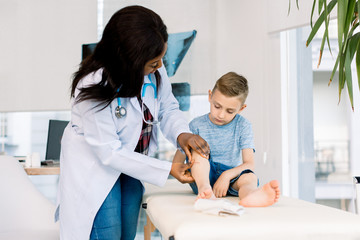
[0,156,60,240]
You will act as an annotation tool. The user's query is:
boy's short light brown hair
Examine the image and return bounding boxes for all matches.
[212,72,249,104]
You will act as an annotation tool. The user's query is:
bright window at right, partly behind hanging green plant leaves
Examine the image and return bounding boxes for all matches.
[282,21,360,211]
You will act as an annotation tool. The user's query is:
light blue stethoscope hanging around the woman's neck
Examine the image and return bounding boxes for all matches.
[115,74,159,125]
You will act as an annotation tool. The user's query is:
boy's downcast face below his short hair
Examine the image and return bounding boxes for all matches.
[209,90,246,125]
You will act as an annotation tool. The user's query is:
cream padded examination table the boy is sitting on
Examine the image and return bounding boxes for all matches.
[143,180,360,240]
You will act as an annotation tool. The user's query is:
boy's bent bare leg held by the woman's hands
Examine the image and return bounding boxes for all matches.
[191,151,216,199]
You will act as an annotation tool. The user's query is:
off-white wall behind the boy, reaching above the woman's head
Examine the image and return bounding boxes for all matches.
[98,0,318,192]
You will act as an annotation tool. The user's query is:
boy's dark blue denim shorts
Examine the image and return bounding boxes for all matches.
[189,159,259,196]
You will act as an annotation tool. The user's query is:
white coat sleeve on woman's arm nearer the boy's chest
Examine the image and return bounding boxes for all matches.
[159,66,191,146]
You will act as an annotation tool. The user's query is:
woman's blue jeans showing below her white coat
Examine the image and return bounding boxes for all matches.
[90,174,144,240]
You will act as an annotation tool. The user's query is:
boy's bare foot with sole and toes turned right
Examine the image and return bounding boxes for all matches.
[239,180,280,207]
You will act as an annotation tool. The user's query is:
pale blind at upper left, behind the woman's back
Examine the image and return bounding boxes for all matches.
[0,0,97,111]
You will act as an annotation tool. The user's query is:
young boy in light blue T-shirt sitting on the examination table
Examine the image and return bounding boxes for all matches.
[174,72,280,207]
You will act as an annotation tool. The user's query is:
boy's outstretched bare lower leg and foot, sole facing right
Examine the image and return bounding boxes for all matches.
[233,173,280,207]
